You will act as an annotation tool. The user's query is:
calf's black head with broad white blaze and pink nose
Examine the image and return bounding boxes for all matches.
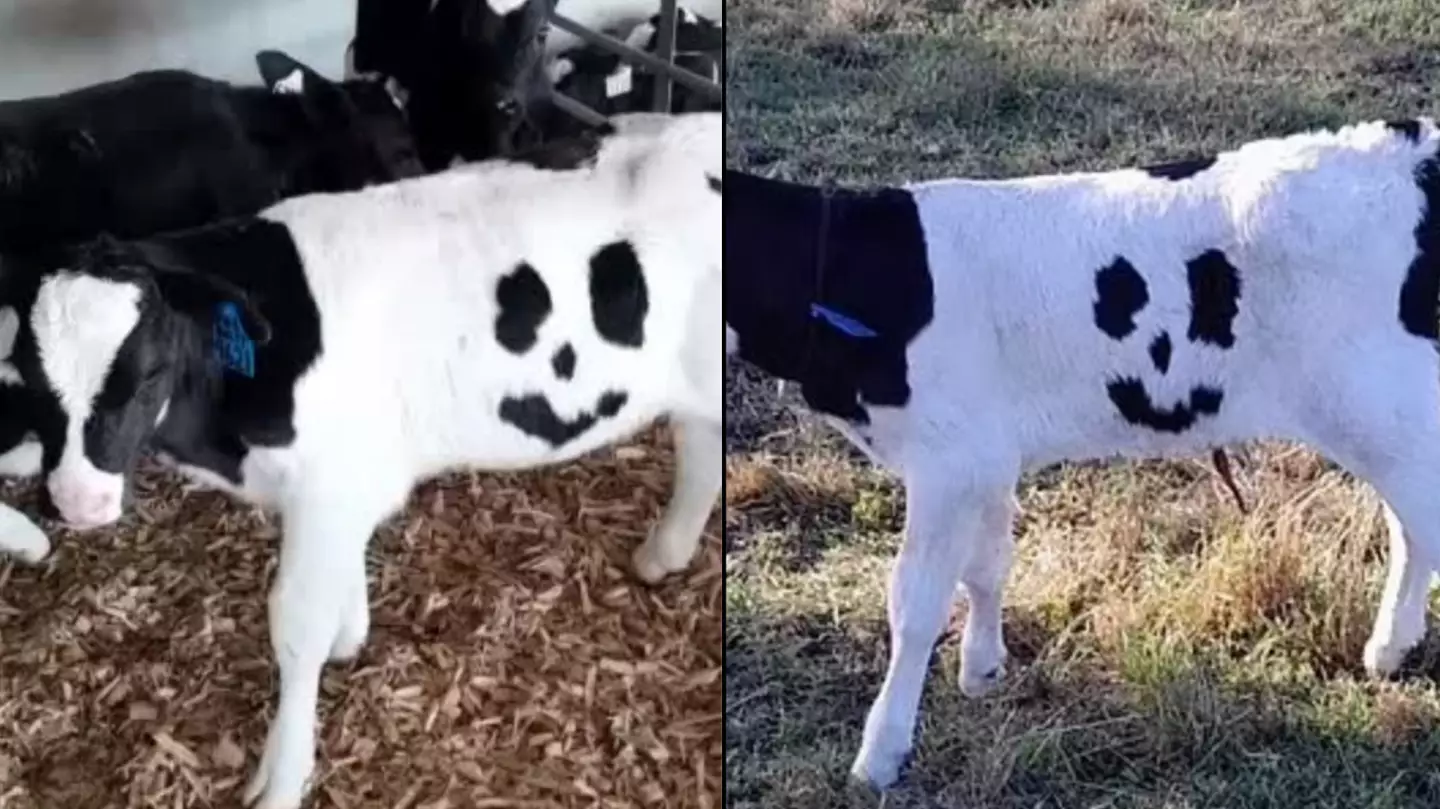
[12,239,269,530]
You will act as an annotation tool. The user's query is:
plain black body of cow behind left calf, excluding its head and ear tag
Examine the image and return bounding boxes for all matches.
[0,71,279,249]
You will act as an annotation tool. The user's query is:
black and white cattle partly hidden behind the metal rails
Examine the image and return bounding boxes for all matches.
[546,7,724,122]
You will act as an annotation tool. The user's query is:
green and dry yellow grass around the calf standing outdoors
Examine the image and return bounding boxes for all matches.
[724,0,1440,809]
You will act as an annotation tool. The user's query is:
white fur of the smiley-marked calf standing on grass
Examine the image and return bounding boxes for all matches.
[730,119,1440,786]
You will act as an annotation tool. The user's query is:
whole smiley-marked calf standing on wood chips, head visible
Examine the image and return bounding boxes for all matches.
[0,114,723,809]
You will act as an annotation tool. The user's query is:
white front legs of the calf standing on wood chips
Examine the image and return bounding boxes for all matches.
[245,483,394,809]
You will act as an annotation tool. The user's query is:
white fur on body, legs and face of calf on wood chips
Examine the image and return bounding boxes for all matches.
[25,108,723,809]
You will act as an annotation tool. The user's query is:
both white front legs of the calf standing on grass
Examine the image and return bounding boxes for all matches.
[850,462,1018,789]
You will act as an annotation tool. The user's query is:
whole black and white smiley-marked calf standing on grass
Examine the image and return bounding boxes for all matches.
[724,119,1440,786]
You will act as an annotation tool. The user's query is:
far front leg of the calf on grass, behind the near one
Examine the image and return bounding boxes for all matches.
[960,497,1017,697]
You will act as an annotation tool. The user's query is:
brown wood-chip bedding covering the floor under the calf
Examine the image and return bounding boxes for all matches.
[0,428,721,809]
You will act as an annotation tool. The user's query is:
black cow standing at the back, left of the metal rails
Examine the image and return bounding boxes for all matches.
[346,0,550,170]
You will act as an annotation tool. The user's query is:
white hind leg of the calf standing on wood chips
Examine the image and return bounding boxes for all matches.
[632,416,724,584]
